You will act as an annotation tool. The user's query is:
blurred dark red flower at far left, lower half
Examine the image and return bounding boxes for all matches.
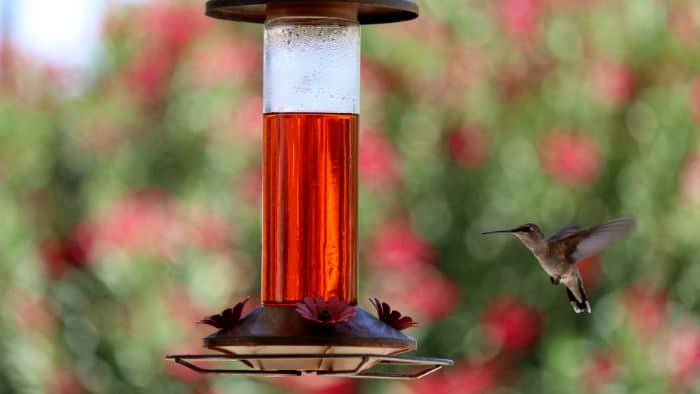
[40,224,94,279]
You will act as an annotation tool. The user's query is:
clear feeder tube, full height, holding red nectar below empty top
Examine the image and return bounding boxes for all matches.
[262,16,360,305]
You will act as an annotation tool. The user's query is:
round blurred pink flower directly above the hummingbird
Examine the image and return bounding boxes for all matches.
[540,131,601,186]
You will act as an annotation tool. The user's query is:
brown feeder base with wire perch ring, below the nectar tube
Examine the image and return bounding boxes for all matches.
[167,306,452,379]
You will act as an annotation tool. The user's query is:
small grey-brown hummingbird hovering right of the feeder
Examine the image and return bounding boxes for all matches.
[482,217,635,313]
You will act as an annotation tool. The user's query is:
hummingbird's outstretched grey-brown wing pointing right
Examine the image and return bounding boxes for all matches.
[560,217,635,262]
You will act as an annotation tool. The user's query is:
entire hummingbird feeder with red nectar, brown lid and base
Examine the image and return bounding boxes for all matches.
[167,0,452,379]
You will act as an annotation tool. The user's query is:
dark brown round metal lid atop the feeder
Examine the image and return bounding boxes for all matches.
[206,0,418,25]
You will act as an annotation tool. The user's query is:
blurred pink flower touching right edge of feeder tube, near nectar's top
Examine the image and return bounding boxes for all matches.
[358,131,400,189]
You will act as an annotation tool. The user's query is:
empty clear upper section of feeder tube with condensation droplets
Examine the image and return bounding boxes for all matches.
[263,17,360,114]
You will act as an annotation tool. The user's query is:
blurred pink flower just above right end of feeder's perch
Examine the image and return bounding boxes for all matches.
[375,266,459,320]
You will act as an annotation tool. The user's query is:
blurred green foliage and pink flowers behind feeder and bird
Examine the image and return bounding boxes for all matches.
[0,0,700,394]
